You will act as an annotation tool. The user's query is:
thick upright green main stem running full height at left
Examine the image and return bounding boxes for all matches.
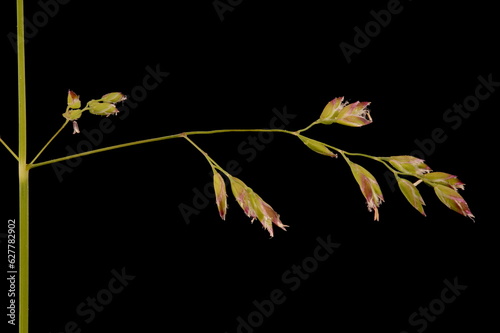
[17,0,29,333]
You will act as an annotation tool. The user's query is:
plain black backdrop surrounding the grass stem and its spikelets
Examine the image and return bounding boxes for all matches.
[0,0,500,333]
